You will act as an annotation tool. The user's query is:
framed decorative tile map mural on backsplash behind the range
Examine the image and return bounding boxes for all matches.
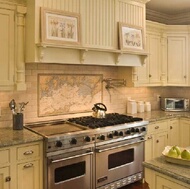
[38,74,103,116]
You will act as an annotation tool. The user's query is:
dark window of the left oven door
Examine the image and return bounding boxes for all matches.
[55,161,86,183]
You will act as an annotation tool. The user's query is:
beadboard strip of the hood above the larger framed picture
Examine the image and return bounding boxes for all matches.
[42,0,80,13]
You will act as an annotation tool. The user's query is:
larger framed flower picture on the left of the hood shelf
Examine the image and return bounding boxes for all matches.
[41,8,80,45]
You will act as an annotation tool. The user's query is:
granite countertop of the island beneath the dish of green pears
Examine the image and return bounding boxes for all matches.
[143,156,190,184]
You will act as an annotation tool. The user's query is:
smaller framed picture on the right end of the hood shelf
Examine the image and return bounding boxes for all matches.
[119,23,144,50]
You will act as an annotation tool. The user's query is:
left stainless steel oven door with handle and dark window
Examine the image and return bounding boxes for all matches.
[47,150,93,189]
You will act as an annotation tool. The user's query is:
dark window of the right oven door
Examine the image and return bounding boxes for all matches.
[108,148,134,169]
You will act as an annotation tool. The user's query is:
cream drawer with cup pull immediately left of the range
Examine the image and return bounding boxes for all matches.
[17,144,40,160]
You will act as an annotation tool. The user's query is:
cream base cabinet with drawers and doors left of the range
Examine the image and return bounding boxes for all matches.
[0,141,43,189]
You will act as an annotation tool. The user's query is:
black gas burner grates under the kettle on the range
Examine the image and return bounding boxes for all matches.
[68,113,143,129]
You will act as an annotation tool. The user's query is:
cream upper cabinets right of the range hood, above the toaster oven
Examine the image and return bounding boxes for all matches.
[119,21,190,86]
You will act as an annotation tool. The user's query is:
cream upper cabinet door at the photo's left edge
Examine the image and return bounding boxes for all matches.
[0,9,15,89]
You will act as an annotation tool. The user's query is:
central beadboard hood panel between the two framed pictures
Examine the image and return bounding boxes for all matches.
[81,0,116,49]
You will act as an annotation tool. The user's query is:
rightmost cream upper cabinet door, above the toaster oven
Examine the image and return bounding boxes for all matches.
[167,26,190,86]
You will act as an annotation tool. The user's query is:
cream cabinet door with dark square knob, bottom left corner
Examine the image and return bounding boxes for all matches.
[0,167,11,189]
